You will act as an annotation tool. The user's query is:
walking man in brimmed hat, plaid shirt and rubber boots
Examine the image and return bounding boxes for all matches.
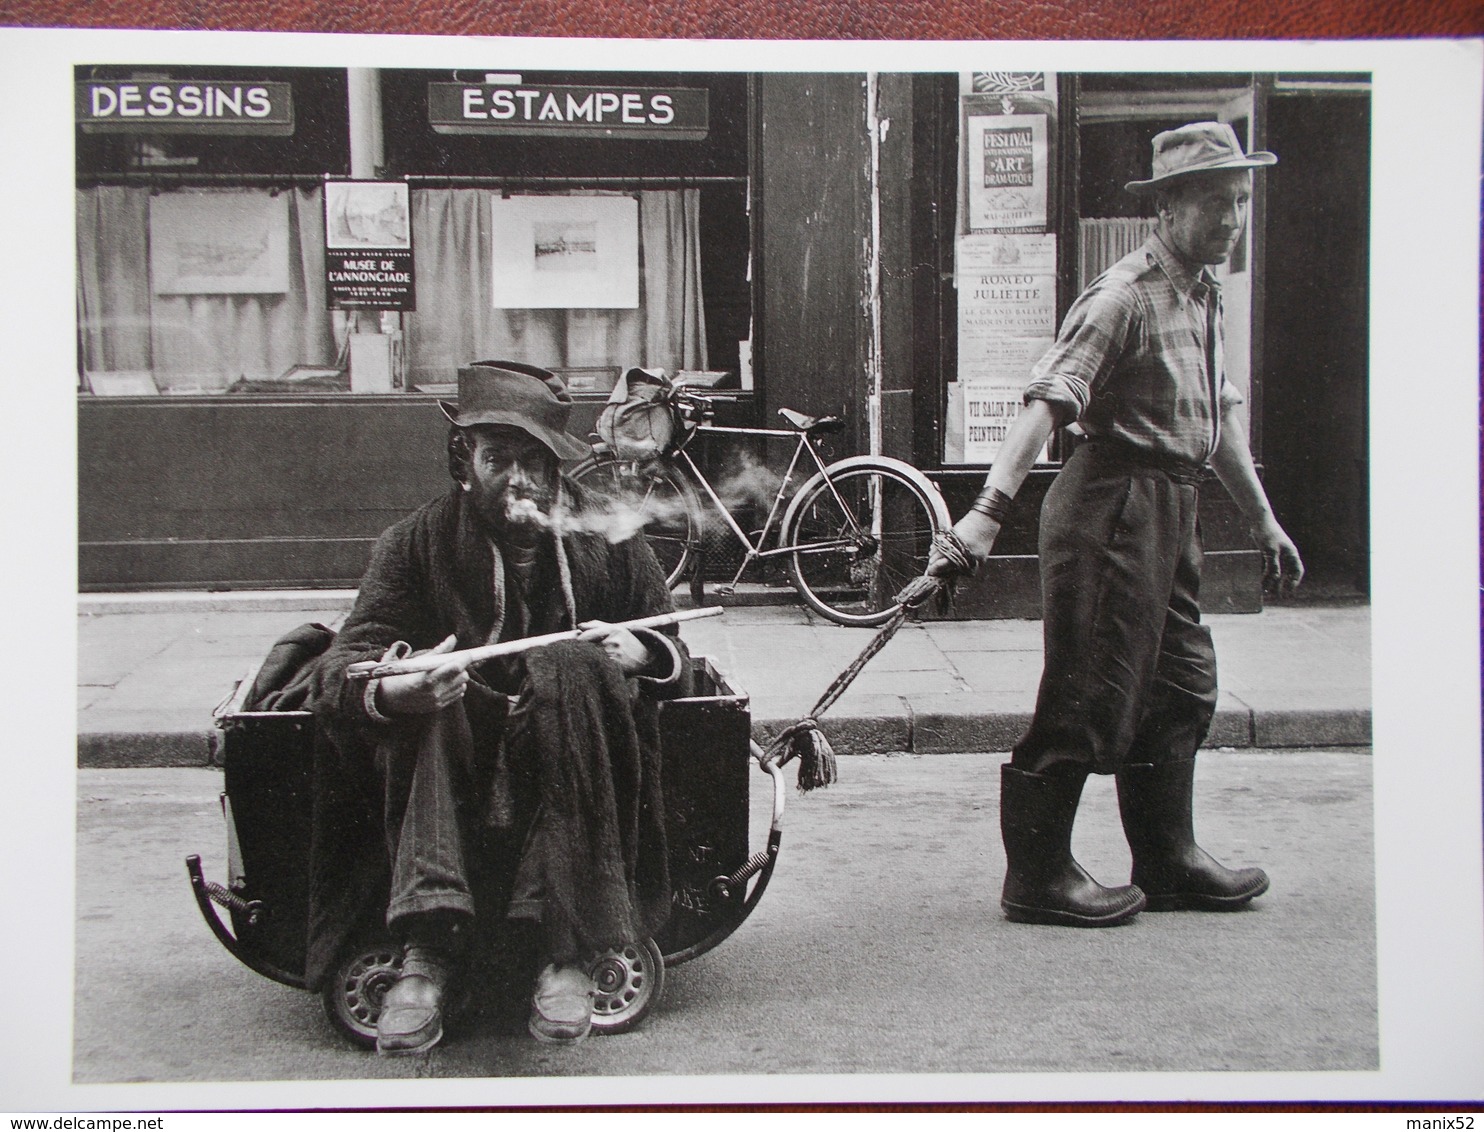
[929,122,1303,927]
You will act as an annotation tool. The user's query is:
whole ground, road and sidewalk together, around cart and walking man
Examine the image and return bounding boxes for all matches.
[60,592,1380,1105]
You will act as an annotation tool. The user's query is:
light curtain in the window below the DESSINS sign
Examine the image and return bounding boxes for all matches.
[77,187,335,392]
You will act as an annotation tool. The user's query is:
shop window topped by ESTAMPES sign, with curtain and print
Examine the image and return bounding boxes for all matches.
[381,68,751,396]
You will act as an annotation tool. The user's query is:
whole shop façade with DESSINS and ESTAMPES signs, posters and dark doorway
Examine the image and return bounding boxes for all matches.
[76,59,1368,616]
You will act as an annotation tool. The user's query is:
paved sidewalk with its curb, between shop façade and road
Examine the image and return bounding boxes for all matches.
[77,590,1371,767]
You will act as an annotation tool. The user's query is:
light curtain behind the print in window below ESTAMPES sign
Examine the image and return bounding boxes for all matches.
[407,188,706,384]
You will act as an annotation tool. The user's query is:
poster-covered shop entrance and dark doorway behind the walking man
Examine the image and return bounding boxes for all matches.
[890,73,1370,616]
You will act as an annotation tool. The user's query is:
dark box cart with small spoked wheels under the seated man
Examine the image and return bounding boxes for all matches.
[186,657,785,1046]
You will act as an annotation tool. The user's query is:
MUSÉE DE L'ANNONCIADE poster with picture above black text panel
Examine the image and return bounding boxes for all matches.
[325,181,417,310]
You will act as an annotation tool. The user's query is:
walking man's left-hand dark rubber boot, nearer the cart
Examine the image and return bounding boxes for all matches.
[1000,763,1144,927]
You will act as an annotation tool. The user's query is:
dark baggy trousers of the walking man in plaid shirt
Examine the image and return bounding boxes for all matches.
[1011,441,1217,774]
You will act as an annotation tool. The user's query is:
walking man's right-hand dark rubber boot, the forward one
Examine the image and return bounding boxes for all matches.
[1117,758,1267,912]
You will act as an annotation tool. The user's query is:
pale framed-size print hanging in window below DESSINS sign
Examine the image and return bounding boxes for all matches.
[150,188,288,295]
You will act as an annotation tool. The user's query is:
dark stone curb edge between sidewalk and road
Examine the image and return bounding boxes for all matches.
[77,703,1371,769]
